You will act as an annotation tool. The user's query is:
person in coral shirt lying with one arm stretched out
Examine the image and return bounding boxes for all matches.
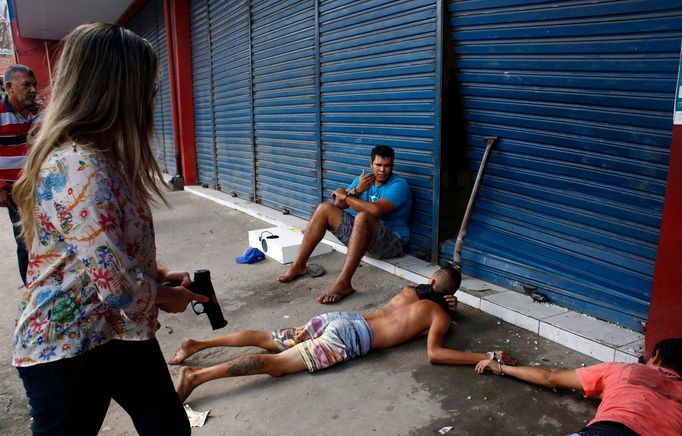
[476,338,682,436]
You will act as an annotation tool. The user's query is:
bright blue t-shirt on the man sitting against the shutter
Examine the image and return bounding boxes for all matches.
[346,174,412,244]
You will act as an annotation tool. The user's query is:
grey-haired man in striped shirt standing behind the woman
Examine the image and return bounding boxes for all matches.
[0,64,38,283]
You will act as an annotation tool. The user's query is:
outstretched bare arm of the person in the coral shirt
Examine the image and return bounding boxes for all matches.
[476,359,583,390]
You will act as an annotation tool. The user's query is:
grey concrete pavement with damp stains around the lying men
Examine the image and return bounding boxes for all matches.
[0,192,596,436]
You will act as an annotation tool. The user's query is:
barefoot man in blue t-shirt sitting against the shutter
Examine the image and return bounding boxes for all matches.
[279,145,412,304]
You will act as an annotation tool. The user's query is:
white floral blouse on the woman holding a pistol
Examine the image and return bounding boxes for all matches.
[13,145,157,366]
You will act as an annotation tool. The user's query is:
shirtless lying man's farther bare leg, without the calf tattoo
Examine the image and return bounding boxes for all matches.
[168,330,279,365]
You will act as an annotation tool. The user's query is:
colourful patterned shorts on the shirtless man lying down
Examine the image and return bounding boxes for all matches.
[272,312,372,372]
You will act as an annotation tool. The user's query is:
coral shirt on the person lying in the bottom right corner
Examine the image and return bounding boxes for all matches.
[576,362,682,436]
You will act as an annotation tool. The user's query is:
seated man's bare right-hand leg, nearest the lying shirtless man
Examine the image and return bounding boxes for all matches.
[319,212,379,304]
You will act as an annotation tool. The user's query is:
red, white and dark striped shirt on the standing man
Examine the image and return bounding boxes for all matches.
[0,97,37,188]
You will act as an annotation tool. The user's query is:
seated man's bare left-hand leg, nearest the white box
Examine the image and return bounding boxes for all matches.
[278,203,343,283]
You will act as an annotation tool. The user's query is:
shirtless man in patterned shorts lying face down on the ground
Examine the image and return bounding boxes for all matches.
[168,267,513,401]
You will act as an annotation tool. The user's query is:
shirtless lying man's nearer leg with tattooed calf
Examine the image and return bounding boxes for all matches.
[175,349,307,401]
